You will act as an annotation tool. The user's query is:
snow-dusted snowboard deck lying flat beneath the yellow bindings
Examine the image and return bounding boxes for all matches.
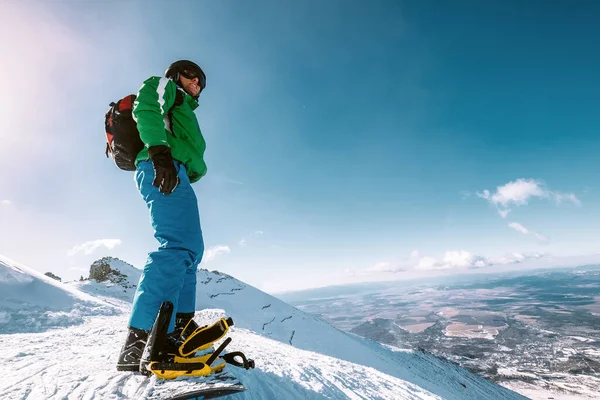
[144,371,246,400]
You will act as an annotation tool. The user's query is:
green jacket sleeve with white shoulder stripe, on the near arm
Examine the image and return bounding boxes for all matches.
[133,76,177,147]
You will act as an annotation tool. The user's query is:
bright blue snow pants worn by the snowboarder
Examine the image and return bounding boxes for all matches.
[129,161,204,333]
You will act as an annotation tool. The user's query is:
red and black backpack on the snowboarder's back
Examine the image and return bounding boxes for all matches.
[104,89,184,171]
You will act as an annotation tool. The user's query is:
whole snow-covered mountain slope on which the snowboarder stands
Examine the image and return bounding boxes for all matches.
[0,262,523,399]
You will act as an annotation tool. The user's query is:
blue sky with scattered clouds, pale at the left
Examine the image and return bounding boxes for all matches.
[0,0,600,292]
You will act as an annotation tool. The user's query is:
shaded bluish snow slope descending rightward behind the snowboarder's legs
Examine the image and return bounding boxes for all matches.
[191,270,521,399]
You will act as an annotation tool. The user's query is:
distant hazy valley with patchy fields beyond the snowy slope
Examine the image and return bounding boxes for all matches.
[282,265,600,399]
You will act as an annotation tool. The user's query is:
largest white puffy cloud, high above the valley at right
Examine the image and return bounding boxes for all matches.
[477,179,581,218]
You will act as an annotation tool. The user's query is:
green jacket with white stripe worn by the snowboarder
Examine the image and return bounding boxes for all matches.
[133,76,206,183]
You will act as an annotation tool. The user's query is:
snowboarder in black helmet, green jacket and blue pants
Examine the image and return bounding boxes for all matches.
[117,60,211,371]
